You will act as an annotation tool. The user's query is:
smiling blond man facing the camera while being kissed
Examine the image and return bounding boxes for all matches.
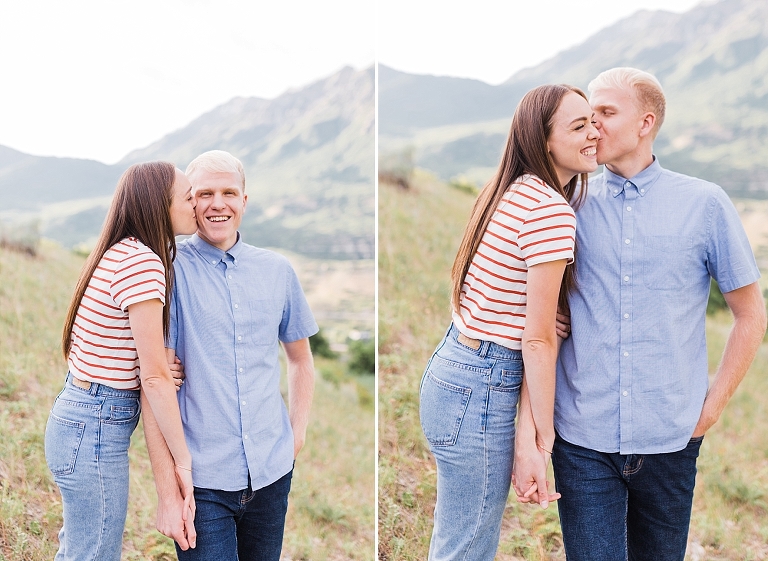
[144,150,317,561]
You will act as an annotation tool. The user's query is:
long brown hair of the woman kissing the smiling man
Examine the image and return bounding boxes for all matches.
[61,162,176,360]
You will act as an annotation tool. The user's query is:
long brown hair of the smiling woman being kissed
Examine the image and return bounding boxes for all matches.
[451,84,588,313]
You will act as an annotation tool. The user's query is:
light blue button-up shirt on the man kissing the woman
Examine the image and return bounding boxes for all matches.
[555,159,760,454]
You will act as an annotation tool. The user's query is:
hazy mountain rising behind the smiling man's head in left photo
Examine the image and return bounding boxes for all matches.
[121,68,375,258]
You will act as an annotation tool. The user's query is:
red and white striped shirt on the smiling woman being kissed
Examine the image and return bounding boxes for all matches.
[453,175,576,350]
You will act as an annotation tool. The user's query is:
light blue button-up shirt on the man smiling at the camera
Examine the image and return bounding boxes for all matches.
[166,234,317,491]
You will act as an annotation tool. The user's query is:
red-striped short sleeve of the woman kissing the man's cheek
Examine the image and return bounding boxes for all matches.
[110,246,165,312]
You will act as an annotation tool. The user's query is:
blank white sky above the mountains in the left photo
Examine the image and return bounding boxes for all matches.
[0,0,376,163]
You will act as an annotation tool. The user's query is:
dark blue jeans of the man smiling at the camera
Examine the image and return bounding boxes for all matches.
[176,470,293,561]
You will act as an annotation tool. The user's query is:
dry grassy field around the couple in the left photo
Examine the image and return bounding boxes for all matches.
[0,245,375,561]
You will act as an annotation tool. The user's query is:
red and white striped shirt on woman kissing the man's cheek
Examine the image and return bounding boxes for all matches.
[68,238,165,389]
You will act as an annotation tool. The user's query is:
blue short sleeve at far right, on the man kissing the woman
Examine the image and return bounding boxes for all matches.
[707,188,760,292]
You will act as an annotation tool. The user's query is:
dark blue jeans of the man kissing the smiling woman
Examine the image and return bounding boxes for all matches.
[552,430,703,561]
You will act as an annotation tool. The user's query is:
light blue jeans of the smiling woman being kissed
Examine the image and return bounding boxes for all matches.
[420,325,523,561]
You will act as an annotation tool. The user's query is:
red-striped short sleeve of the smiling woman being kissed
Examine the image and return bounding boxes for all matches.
[517,197,576,267]
